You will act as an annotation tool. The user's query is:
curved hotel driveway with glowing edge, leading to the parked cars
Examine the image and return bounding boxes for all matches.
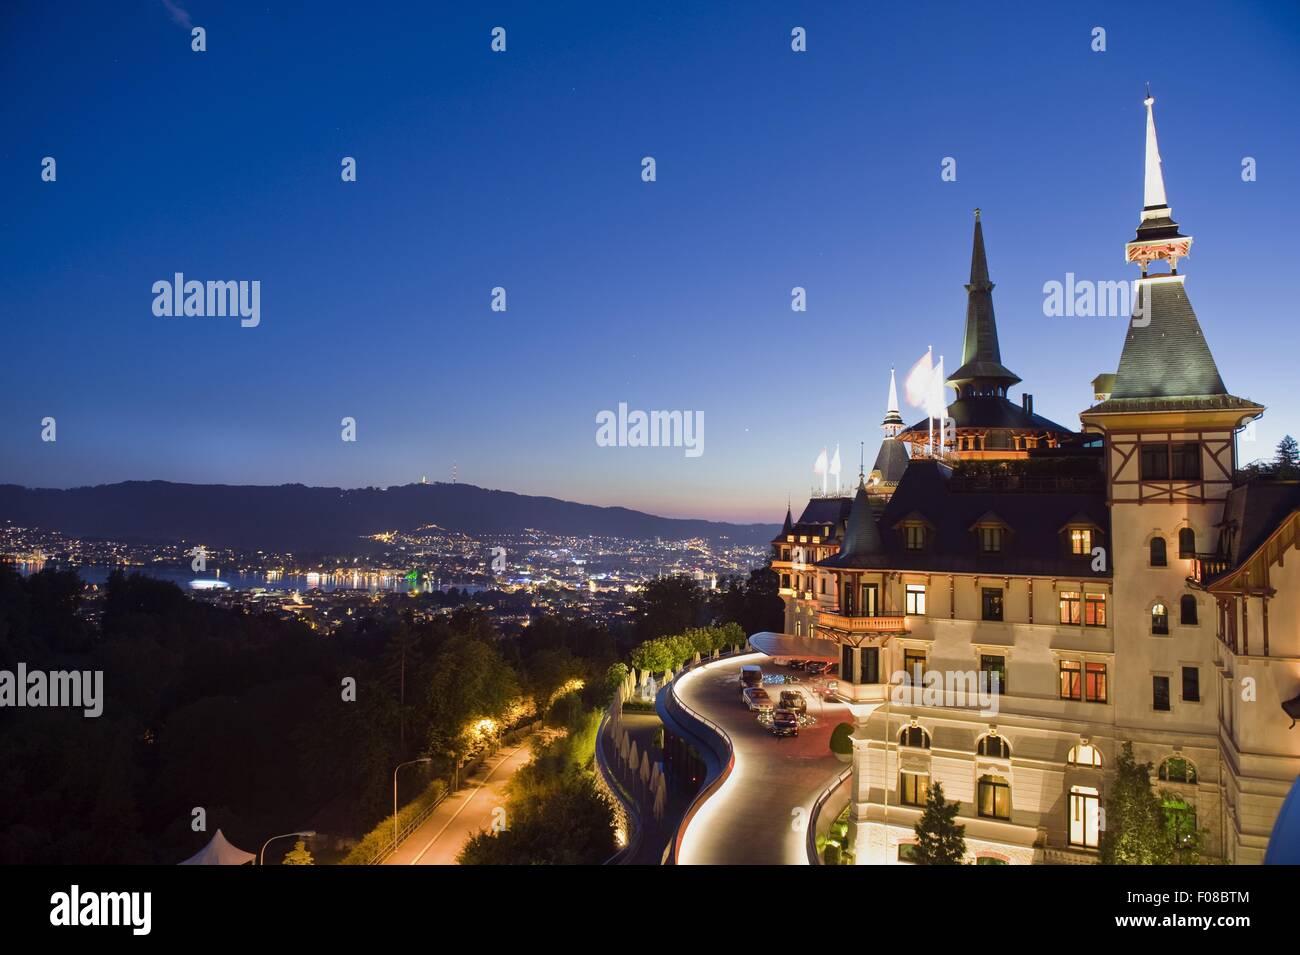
[675,654,853,865]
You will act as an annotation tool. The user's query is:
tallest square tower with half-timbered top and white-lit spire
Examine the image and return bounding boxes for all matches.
[1080,91,1264,846]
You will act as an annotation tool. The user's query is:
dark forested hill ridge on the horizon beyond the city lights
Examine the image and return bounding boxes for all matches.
[0,481,779,552]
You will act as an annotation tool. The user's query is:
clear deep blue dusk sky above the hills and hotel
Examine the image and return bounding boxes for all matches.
[0,0,1300,521]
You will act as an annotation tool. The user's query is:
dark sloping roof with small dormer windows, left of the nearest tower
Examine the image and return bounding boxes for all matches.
[818,460,1110,579]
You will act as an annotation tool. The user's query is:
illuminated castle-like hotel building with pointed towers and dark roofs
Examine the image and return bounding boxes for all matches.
[772,97,1300,864]
